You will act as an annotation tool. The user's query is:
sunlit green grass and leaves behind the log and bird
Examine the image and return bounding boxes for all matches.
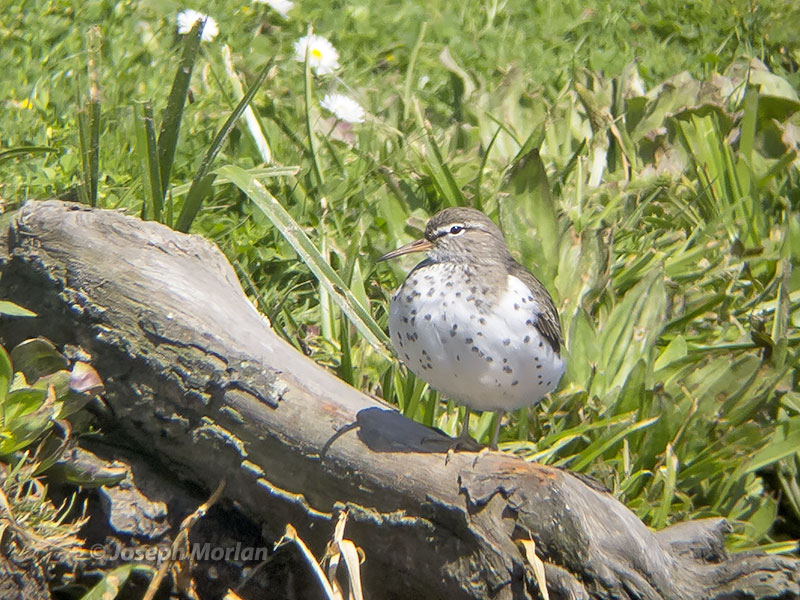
[0,1,800,551]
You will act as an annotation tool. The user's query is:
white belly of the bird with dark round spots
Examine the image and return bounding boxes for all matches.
[389,276,564,410]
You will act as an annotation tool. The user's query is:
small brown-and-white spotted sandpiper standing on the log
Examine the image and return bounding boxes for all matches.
[378,207,564,448]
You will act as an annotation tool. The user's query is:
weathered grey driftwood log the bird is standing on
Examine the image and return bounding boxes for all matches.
[0,201,800,600]
